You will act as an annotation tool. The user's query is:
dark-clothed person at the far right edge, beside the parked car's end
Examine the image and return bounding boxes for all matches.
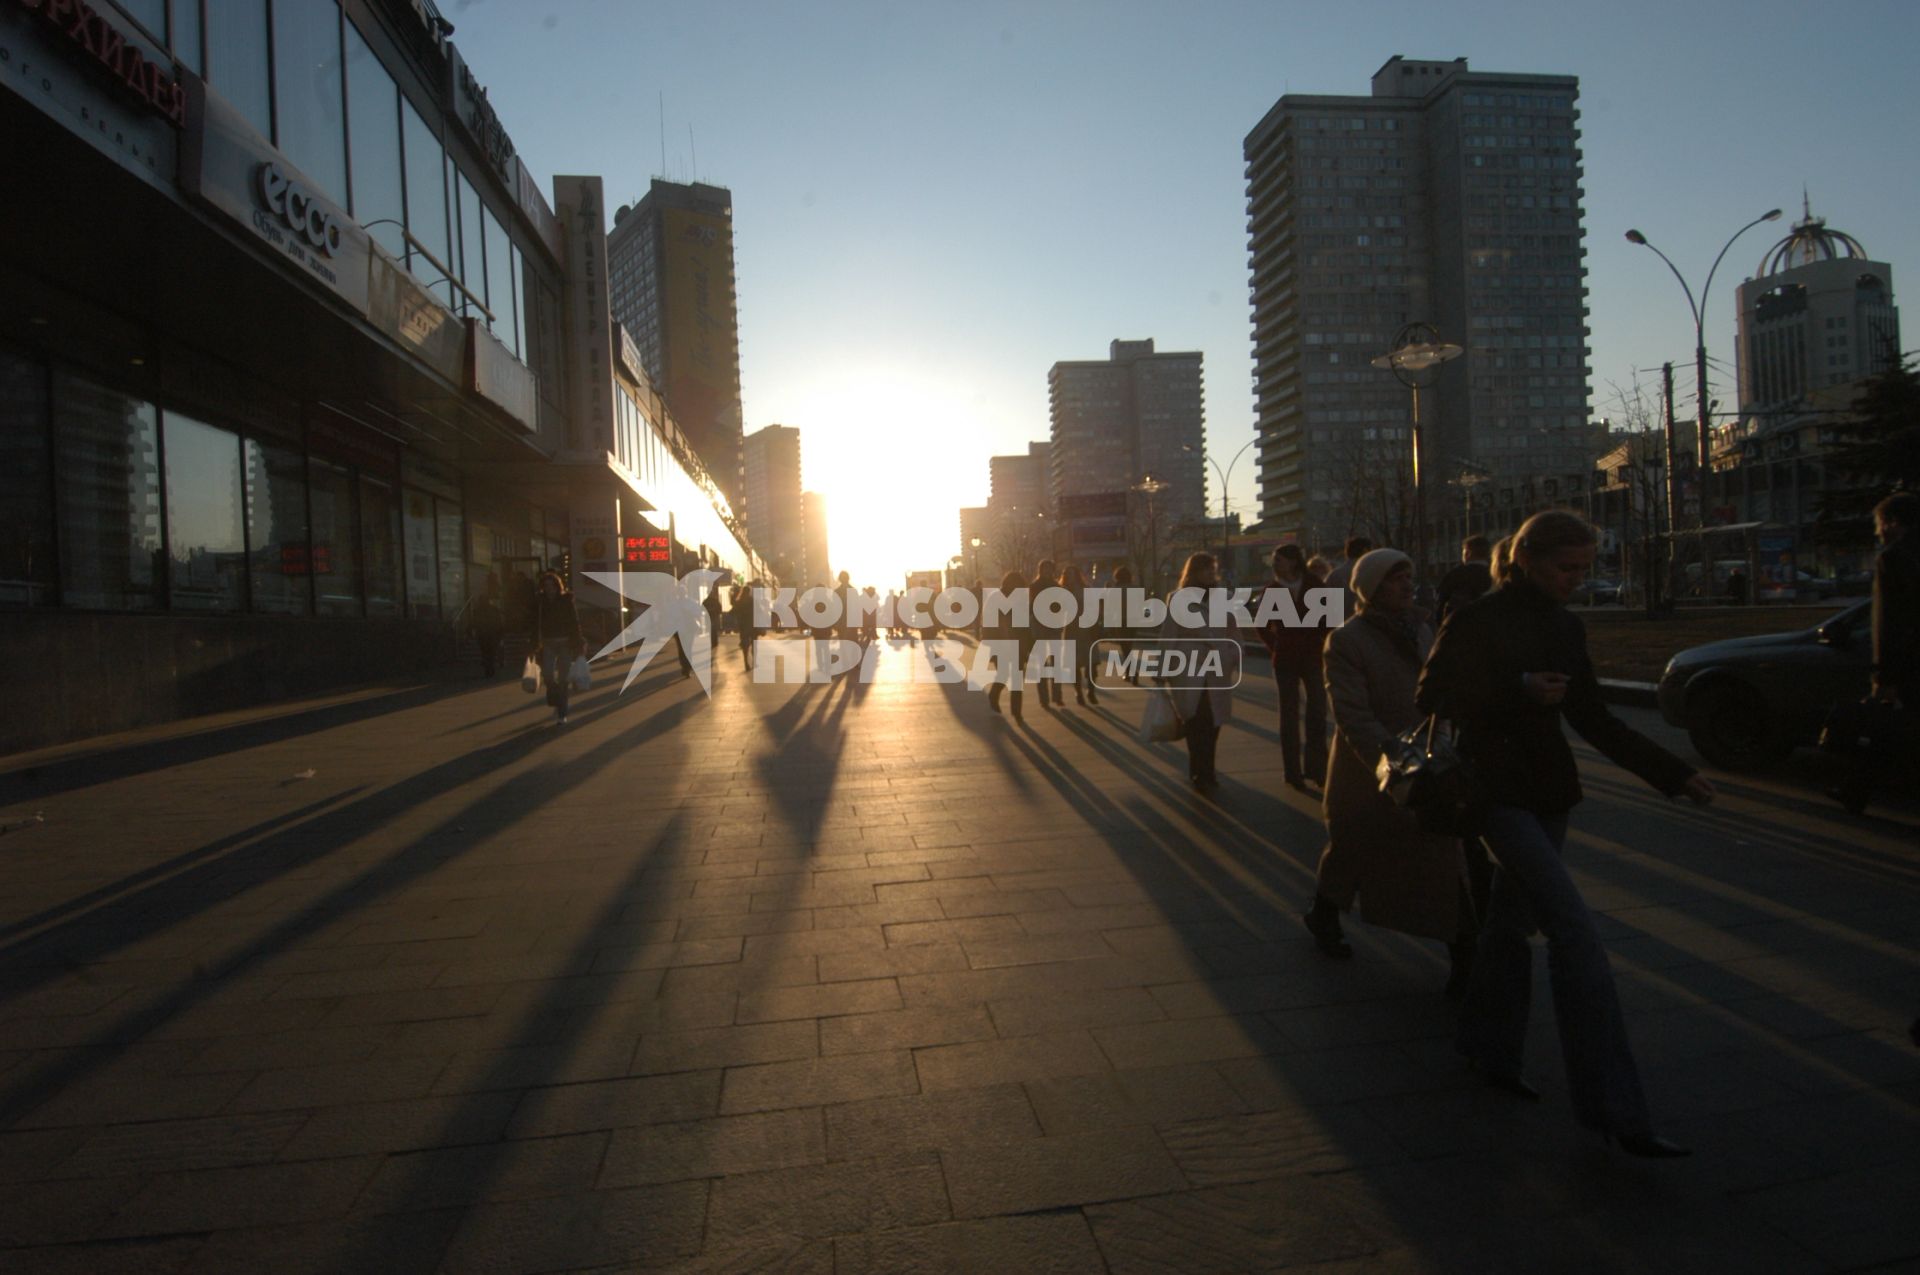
[1828,492,1920,814]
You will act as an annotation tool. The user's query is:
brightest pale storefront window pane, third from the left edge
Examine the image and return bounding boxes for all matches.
[161,411,246,611]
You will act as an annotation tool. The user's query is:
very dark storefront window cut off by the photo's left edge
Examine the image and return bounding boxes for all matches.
[0,349,54,607]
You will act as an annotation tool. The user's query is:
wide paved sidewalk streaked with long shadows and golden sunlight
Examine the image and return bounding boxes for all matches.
[0,645,1920,1273]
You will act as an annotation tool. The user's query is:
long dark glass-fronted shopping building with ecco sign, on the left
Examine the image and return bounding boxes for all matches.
[0,0,751,749]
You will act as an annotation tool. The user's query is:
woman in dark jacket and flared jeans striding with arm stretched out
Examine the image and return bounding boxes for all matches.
[1419,509,1715,1156]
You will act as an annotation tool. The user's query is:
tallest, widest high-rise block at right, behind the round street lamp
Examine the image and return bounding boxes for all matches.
[1244,56,1592,543]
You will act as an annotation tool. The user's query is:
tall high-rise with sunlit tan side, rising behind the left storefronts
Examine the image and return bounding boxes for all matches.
[607,179,745,515]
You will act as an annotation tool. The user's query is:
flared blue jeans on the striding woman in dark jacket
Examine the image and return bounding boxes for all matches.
[1459,806,1651,1135]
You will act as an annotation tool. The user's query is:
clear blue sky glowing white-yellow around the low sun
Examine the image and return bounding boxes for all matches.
[440,0,1920,584]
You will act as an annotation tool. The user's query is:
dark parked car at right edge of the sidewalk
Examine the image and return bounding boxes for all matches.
[1659,603,1872,770]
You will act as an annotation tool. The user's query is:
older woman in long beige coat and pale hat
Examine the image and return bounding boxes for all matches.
[1306,549,1475,997]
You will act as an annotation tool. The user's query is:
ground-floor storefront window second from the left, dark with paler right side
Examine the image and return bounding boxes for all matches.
[54,374,165,611]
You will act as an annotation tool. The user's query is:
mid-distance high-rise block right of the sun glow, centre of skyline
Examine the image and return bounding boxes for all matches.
[1046,340,1206,566]
